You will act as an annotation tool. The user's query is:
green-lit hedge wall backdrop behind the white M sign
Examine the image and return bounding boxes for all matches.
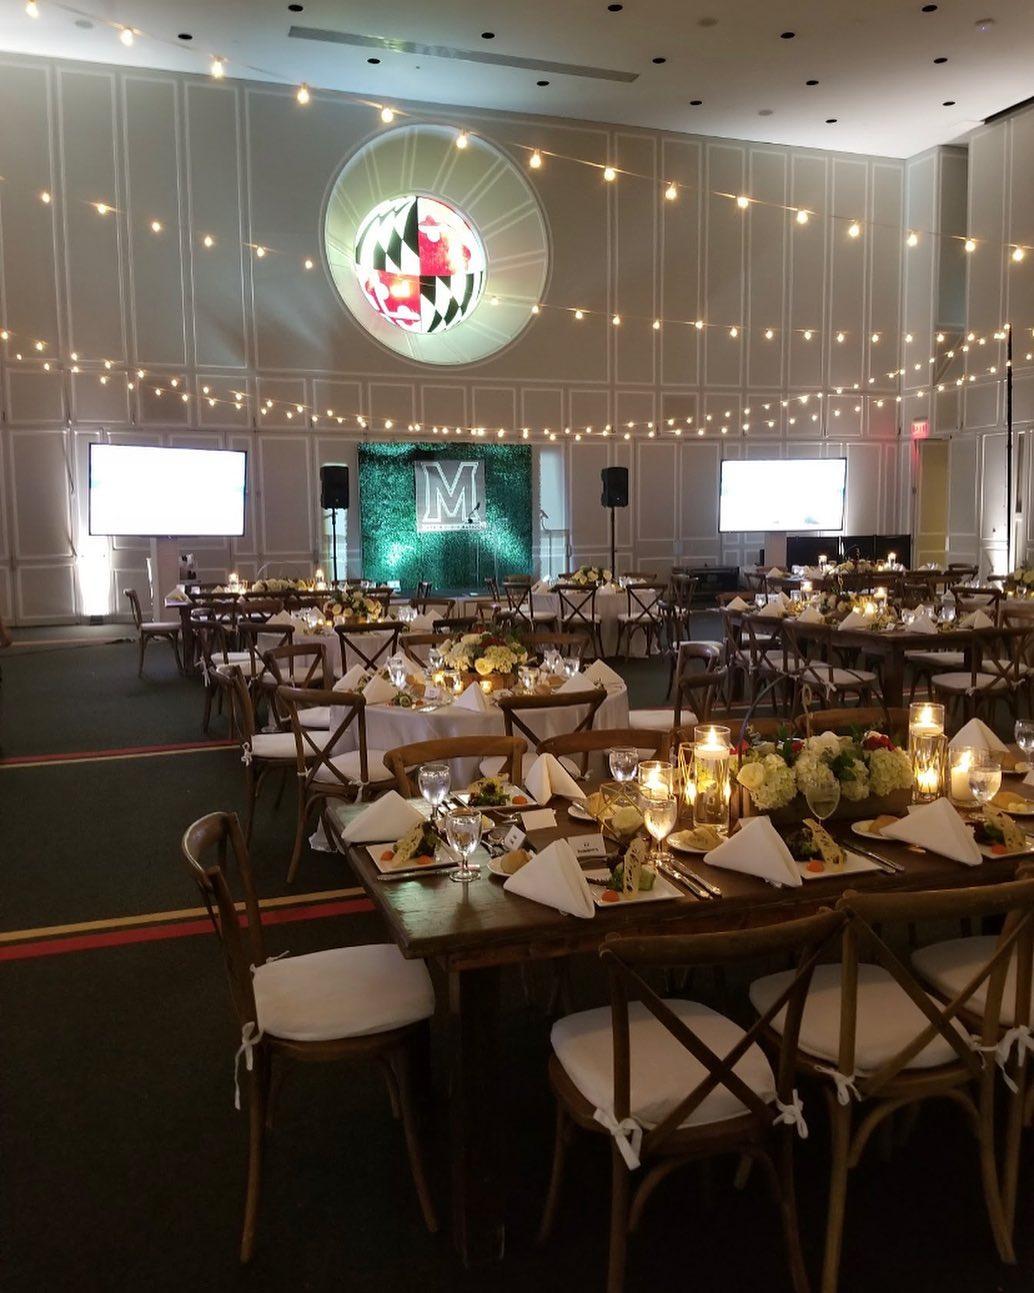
[359,443,531,591]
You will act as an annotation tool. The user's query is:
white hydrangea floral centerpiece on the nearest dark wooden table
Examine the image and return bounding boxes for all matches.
[737,729,913,821]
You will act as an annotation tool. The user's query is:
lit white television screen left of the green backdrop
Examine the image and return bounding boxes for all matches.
[89,445,248,537]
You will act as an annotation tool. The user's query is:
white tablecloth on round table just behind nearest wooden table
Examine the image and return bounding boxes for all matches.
[331,683,628,789]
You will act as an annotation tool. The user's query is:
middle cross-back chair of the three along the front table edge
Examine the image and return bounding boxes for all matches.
[750,877,1034,1293]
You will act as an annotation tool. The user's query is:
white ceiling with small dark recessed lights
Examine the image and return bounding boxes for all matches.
[0,0,1034,156]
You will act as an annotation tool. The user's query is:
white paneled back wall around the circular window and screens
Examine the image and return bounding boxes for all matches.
[0,56,915,623]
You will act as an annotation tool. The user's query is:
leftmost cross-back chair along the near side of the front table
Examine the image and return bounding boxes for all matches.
[539,912,843,1293]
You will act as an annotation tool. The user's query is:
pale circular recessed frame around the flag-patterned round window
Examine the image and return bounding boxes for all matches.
[321,123,551,366]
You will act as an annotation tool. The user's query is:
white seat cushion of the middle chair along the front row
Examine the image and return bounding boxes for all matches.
[750,965,962,1073]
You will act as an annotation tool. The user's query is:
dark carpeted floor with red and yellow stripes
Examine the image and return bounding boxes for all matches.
[0,635,1034,1293]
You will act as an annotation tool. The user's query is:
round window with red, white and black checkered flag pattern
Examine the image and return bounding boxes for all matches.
[354,194,487,335]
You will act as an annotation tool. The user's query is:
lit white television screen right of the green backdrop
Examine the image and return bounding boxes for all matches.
[719,458,848,534]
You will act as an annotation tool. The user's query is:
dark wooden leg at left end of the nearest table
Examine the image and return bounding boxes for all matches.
[448,966,505,1266]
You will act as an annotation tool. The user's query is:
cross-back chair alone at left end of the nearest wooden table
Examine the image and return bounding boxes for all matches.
[181,812,438,1262]
